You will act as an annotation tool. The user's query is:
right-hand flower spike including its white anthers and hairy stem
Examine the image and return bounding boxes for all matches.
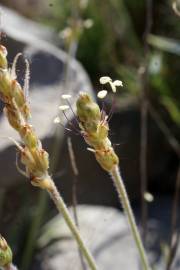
[76,85,151,270]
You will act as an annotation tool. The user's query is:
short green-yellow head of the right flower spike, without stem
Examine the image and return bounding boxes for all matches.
[76,90,119,172]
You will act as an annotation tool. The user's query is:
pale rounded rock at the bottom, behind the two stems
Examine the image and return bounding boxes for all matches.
[33,206,139,270]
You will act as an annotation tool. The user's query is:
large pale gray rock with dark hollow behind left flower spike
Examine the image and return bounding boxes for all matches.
[0,7,92,188]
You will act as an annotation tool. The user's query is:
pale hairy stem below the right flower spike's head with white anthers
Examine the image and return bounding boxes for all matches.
[111,166,151,270]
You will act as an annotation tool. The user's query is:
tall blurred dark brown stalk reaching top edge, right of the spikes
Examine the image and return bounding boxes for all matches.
[140,0,153,244]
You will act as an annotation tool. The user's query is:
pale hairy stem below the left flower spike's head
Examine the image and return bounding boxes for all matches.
[47,180,98,270]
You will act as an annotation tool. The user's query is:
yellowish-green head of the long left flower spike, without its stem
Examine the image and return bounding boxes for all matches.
[0,46,49,188]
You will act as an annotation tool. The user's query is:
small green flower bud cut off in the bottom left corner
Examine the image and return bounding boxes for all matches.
[0,236,12,267]
